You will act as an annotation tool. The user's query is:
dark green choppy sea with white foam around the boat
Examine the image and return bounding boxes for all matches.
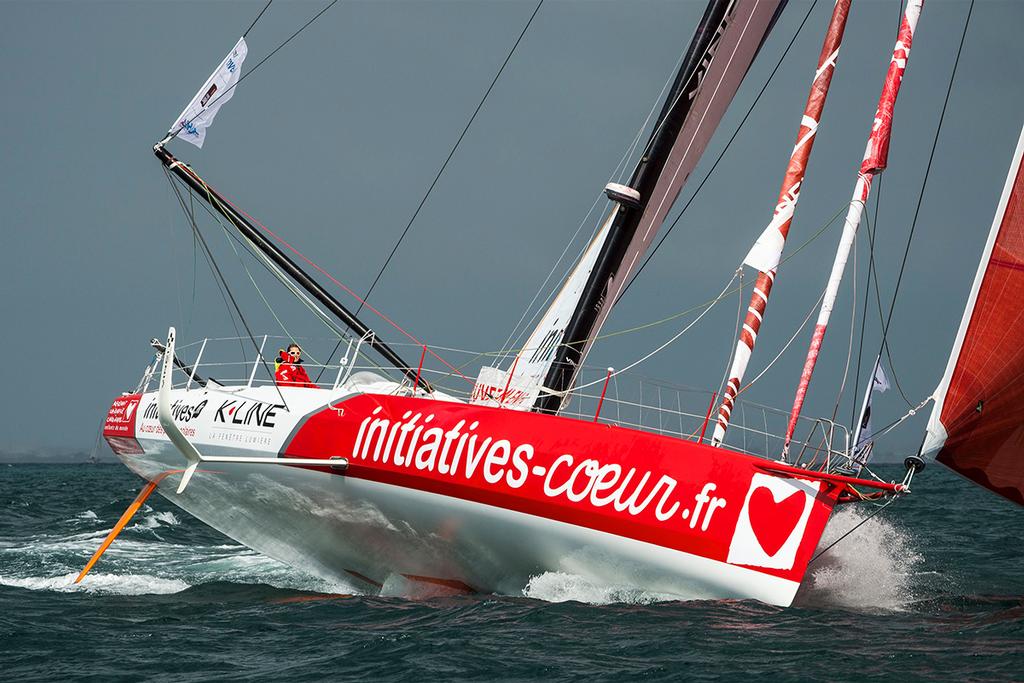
[0,465,1024,682]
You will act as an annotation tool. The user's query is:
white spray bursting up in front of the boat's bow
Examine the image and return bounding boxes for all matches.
[797,508,923,610]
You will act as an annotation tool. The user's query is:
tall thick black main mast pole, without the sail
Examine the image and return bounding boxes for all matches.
[534,0,736,413]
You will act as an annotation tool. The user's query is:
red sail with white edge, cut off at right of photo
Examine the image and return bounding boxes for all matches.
[923,124,1024,505]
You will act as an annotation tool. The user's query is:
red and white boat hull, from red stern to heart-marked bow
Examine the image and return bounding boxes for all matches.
[103,382,843,605]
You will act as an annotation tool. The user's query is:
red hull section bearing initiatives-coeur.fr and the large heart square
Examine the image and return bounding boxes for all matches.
[281,394,838,582]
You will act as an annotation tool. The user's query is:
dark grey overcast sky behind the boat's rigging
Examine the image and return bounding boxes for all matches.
[0,0,1024,462]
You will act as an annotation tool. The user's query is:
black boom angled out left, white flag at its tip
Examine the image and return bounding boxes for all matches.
[153,144,433,392]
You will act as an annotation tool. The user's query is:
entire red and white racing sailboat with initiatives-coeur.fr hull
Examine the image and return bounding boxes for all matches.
[86,0,991,605]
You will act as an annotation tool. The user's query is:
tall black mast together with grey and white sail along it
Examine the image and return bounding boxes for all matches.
[513,0,785,413]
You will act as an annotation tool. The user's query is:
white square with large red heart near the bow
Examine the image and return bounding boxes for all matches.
[726,474,821,569]
